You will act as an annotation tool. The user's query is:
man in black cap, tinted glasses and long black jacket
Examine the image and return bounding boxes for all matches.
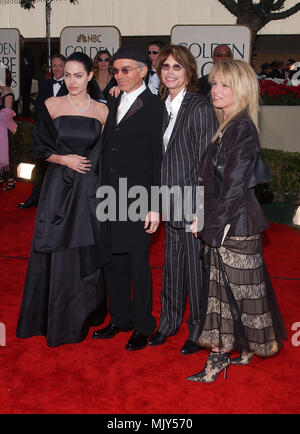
[93,46,163,350]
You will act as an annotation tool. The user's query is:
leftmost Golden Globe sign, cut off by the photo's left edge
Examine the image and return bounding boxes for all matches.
[0,29,20,99]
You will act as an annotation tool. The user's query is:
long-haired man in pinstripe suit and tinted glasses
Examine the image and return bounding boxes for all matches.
[149,45,217,354]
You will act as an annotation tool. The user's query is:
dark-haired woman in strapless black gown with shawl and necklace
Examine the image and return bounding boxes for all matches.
[17,53,108,346]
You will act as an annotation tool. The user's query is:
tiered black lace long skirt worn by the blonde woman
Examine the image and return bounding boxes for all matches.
[198,234,287,357]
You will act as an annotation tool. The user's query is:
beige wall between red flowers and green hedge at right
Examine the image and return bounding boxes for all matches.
[260,106,300,152]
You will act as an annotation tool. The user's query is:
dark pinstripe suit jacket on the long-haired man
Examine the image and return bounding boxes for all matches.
[161,92,217,228]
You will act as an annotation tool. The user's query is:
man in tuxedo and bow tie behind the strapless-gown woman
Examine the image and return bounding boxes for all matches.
[18,54,68,209]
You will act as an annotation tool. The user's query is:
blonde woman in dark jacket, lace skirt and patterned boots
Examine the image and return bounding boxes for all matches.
[188,60,286,383]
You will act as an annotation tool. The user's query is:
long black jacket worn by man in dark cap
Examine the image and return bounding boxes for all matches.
[102,89,163,251]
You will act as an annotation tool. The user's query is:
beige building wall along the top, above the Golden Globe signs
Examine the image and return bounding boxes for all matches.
[0,0,300,38]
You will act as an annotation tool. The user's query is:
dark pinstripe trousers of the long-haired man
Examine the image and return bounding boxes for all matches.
[158,223,203,341]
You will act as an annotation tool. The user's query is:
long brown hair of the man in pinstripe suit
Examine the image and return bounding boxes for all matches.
[156,45,199,99]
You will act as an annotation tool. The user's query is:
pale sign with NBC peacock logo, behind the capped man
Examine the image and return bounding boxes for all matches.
[60,26,121,59]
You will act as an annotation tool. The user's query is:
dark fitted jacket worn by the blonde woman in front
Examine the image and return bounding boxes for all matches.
[200,114,268,247]
